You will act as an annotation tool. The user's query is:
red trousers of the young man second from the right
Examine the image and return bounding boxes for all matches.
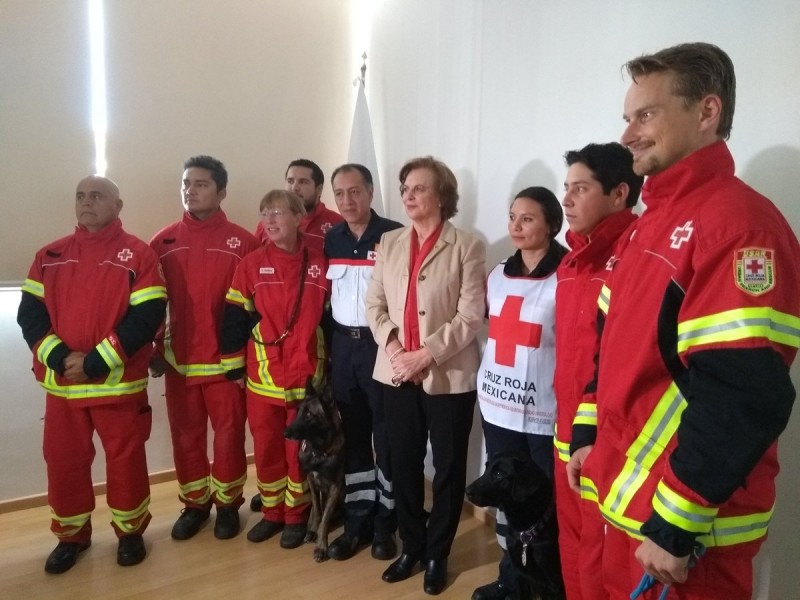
[555,458,608,600]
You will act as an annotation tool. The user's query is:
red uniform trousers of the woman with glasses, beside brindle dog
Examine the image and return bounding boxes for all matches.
[247,390,311,525]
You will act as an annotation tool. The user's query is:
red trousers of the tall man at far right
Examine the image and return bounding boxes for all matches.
[602,525,761,600]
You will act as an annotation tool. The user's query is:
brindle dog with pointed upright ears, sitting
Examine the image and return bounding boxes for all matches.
[283,378,344,562]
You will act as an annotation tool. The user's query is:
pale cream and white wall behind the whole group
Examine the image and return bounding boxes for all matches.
[0,0,800,599]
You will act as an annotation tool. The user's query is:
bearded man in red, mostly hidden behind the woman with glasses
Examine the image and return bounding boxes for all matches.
[256,158,342,250]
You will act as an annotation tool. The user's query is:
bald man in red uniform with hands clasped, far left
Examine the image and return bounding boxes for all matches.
[17,176,166,574]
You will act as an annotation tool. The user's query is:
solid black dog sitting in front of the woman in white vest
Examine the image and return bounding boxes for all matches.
[466,452,566,600]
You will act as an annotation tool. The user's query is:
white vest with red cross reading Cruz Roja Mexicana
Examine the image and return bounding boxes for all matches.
[478,262,557,435]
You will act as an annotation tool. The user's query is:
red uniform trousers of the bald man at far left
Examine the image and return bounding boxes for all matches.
[43,392,153,543]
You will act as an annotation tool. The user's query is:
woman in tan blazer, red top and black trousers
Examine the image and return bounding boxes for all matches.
[367,157,486,594]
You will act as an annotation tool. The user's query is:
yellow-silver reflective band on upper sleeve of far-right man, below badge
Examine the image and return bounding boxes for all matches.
[678,306,800,352]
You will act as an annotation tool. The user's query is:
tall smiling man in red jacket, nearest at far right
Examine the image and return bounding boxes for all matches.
[568,43,800,600]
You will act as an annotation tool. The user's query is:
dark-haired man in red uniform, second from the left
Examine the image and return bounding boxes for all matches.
[150,156,259,540]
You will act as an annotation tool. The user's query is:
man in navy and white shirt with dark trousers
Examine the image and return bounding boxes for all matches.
[325,163,401,560]
